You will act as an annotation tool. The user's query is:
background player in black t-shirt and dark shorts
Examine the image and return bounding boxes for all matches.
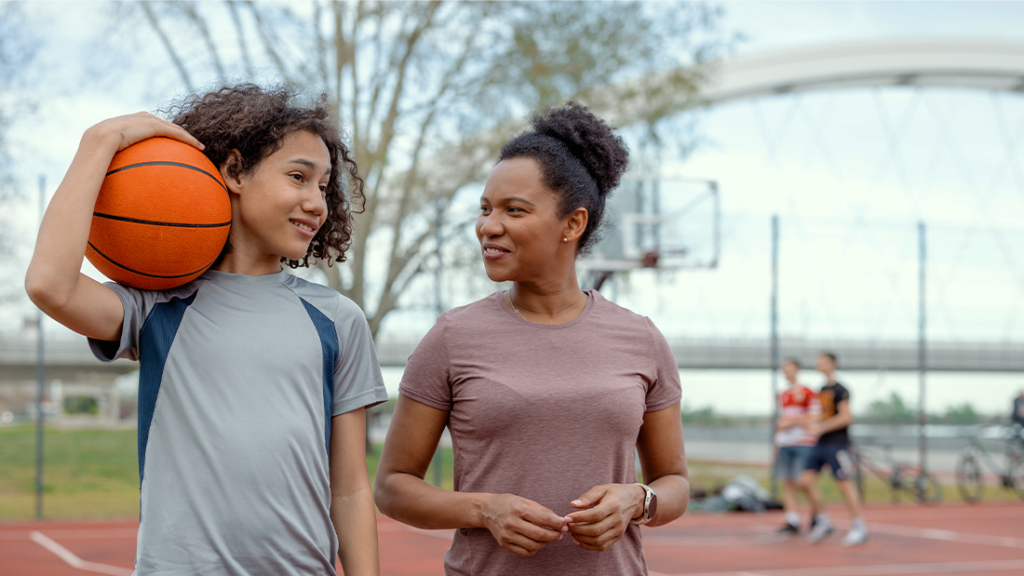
[800,352,867,546]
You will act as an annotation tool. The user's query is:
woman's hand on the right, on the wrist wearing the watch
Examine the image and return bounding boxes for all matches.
[565,484,643,551]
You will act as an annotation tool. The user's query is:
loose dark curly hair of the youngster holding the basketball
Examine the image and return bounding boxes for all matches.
[168,83,362,269]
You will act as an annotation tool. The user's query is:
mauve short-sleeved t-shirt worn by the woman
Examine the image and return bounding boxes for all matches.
[399,291,682,576]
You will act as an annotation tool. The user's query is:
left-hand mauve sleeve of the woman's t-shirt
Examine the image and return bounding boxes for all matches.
[398,315,452,412]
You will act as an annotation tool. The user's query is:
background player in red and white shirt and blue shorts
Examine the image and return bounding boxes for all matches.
[774,358,821,534]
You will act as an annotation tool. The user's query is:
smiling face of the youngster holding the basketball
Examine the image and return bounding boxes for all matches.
[229,131,331,262]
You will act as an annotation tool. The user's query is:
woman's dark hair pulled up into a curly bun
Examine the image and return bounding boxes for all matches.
[498,100,630,255]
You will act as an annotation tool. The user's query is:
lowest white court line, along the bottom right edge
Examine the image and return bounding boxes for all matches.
[648,560,1024,576]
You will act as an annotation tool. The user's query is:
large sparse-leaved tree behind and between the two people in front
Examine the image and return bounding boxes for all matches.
[120,0,729,335]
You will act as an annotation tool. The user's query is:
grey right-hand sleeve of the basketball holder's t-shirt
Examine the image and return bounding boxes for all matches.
[332,298,387,416]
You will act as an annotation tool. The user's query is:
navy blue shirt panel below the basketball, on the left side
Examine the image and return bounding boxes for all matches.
[138,292,197,485]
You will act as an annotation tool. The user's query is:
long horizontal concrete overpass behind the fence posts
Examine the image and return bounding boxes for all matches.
[0,334,1024,375]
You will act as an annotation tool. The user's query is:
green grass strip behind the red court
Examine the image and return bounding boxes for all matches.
[0,425,1018,521]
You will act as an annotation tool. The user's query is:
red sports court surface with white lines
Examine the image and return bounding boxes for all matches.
[0,502,1024,576]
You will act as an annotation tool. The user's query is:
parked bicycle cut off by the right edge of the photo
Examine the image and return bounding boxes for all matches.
[956,425,1024,504]
